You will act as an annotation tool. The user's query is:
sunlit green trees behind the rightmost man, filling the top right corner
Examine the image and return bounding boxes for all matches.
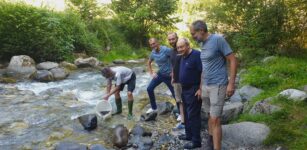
[194,0,307,63]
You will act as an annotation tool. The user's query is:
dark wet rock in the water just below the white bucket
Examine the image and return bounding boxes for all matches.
[78,114,97,131]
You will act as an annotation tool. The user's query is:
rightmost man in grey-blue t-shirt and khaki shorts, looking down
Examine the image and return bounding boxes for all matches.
[190,20,237,150]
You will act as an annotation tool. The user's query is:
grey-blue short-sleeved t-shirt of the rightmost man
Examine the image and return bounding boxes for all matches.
[200,34,232,85]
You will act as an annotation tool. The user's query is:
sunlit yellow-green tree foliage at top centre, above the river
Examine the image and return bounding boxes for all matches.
[112,0,178,47]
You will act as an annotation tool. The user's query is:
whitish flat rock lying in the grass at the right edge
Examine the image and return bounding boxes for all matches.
[279,89,307,101]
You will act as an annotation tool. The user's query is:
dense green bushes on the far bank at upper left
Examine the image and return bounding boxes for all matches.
[0,2,99,61]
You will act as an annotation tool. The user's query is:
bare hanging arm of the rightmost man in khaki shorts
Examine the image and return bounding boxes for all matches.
[226,53,237,97]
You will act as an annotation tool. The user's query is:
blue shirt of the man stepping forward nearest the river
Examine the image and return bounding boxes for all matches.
[149,46,172,75]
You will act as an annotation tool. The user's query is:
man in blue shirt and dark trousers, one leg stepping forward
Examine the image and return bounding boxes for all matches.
[146,38,175,113]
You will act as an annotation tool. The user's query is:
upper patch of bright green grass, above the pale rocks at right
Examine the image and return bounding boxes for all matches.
[242,57,307,90]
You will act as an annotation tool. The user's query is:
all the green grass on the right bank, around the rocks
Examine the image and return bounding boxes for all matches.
[236,57,307,150]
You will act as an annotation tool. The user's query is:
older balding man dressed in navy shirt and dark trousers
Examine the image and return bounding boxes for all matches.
[177,38,202,149]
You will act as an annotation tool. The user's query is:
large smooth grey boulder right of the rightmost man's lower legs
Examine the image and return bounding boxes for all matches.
[222,122,270,147]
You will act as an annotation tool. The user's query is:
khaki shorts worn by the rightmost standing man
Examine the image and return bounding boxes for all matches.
[202,85,227,117]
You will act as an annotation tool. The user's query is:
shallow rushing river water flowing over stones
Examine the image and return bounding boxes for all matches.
[0,67,178,149]
